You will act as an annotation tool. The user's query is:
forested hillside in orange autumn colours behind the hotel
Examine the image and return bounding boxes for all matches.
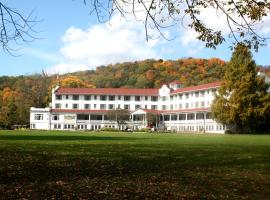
[0,58,270,128]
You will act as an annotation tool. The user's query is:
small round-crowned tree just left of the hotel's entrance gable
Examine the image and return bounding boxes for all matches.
[107,109,129,130]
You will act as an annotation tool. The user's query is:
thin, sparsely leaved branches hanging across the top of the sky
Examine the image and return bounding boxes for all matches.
[0,0,270,51]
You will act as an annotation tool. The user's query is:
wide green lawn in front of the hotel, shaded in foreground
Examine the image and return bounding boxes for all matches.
[0,131,270,199]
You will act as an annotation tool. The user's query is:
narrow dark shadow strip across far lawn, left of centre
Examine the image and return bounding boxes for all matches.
[0,135,147,141]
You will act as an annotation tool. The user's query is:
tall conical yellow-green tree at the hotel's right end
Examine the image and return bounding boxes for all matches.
[212,44,270,132]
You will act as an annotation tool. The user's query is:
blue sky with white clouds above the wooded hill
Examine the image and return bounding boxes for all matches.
[0,0,270,76]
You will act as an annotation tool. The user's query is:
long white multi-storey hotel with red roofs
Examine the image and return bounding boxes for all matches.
[30,82,225,133]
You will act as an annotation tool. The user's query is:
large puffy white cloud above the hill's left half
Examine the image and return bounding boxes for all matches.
[47,16,160,73]
